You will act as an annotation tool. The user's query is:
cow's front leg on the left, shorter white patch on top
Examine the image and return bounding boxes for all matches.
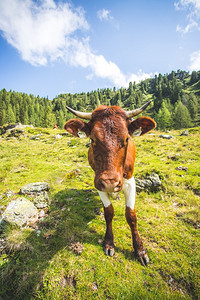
[98,191,115,256]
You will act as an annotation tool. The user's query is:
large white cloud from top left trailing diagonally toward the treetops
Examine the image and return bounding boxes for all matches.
[0,0,152,87]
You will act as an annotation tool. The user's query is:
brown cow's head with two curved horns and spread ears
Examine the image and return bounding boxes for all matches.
[64,101,156,192]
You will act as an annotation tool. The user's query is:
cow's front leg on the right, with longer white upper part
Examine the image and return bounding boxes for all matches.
[123,177,149,265]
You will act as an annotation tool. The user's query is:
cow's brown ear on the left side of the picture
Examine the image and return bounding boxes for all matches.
[64,119,90,137]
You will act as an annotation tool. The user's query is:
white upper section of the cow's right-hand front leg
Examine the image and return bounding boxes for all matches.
[122,177,136,209]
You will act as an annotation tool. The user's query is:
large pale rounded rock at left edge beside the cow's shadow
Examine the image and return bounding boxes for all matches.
[2,197,38,227]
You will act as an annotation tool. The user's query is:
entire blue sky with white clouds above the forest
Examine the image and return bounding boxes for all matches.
[0,0,200,99]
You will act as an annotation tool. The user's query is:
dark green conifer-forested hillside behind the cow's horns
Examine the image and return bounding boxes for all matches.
[0,70,200,130]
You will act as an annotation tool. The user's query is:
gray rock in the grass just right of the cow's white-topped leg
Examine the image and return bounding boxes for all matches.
[135,173,162,192]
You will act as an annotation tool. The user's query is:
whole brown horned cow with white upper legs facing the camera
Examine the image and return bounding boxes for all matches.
[64,101,156,265]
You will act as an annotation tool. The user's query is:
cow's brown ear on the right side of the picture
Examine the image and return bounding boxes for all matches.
[128,117,156,135]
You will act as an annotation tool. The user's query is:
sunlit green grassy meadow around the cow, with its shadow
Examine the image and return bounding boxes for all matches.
[0,128,200,300]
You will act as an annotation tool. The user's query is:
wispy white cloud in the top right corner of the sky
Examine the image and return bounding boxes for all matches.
[174,0,200,34]
